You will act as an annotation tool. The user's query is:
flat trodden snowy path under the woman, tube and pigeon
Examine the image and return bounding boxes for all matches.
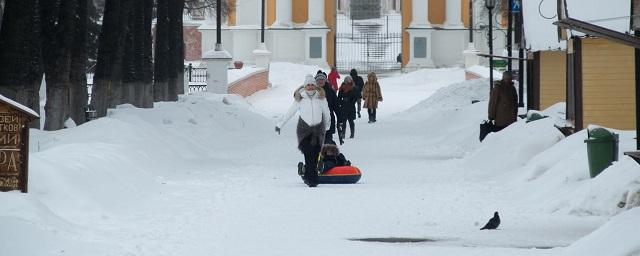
[79,115,593,255]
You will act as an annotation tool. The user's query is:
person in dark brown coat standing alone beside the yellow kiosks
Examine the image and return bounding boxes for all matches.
[489,71,518,132]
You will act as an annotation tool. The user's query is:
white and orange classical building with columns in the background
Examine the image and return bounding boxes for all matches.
[198,0,506,68]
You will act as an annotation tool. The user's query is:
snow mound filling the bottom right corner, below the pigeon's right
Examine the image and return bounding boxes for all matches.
[562,208,640,256]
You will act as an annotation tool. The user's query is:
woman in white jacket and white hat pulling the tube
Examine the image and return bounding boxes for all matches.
[276,75,331,187]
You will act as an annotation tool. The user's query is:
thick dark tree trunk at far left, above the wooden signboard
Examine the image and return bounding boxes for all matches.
[0,0,43,128]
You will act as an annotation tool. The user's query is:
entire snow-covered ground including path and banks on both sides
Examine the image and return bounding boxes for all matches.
[0,63,640,256]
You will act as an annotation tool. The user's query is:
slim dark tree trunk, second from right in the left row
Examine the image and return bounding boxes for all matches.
[153,0,170,102]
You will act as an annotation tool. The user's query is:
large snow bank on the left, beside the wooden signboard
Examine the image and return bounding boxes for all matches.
[0,93,272,255]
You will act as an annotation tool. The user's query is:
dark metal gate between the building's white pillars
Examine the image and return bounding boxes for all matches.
[336,15,402,72]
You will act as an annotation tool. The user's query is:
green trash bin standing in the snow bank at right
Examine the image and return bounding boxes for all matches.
[584,128,618,178]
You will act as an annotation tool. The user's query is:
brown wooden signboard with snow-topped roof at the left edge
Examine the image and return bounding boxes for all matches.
[0,96,38,193]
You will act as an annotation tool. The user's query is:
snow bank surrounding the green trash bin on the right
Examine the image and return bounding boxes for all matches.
[520,127,640,216]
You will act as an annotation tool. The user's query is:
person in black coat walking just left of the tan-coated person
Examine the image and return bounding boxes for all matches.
[338,76,358,139]
